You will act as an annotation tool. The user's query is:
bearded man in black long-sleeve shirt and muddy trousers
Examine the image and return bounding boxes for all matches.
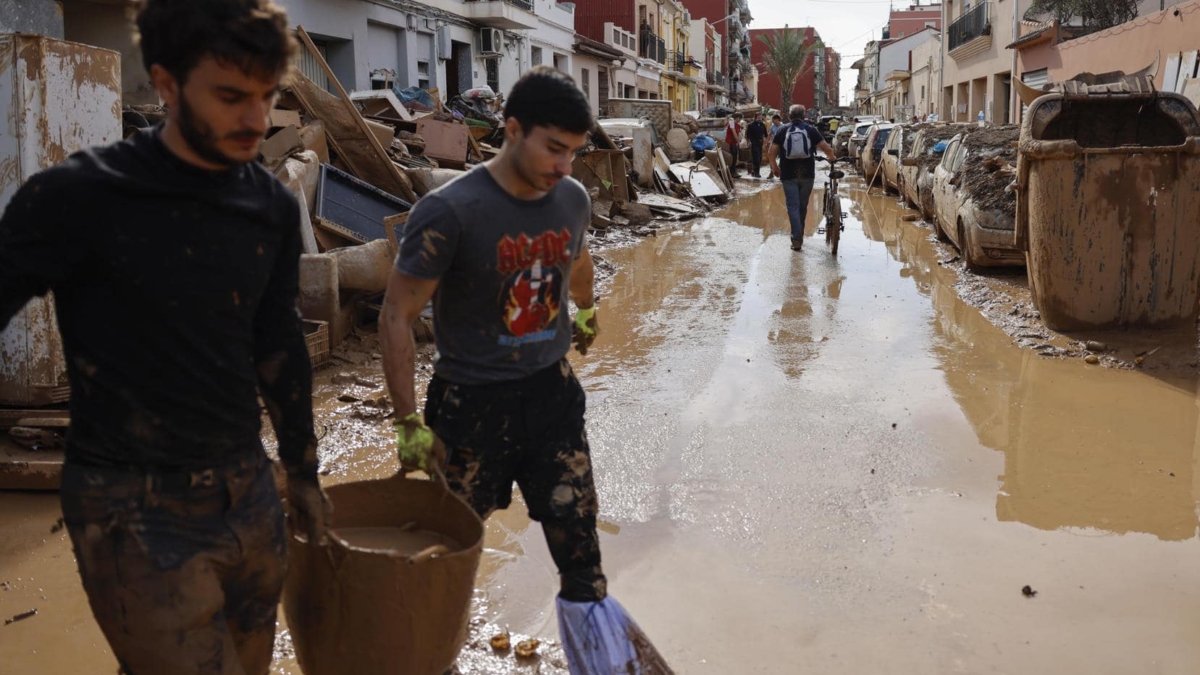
[0,0,328,675]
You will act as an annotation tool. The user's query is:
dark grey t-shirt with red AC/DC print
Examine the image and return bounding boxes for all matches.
[396,166,592,384]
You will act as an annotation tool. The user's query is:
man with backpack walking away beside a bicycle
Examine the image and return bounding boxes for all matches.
[767,104,834,251]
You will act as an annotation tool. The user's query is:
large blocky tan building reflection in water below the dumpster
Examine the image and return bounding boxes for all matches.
[996,365,1198,540]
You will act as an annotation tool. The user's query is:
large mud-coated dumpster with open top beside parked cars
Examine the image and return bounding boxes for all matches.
[1015,91,1200,330]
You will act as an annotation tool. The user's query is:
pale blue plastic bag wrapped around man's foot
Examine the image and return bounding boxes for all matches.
[556,596,673,675]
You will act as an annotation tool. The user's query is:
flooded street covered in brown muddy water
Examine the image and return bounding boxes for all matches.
[0,170,1200,675]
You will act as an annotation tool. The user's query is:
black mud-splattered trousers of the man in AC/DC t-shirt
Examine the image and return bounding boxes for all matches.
[425,359,607,602]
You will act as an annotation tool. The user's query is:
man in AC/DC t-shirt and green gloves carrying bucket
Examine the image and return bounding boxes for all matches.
[380,66,662,675]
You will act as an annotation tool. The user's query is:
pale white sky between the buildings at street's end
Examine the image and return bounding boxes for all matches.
[750,0,902,106]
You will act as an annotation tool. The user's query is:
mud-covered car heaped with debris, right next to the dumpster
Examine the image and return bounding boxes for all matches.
[934,126,1025,269]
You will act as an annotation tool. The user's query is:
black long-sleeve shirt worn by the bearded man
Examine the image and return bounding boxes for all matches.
[0,127,317,474]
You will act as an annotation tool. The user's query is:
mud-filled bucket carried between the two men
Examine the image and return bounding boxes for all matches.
[283,477,484,675]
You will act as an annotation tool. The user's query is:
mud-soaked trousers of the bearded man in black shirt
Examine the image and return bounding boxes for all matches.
[61,450,287,675]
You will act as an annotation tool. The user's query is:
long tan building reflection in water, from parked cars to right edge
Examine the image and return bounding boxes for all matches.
[864,190,1200,540]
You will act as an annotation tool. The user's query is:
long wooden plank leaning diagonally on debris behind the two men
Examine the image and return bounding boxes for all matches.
[292,26,416,203]
